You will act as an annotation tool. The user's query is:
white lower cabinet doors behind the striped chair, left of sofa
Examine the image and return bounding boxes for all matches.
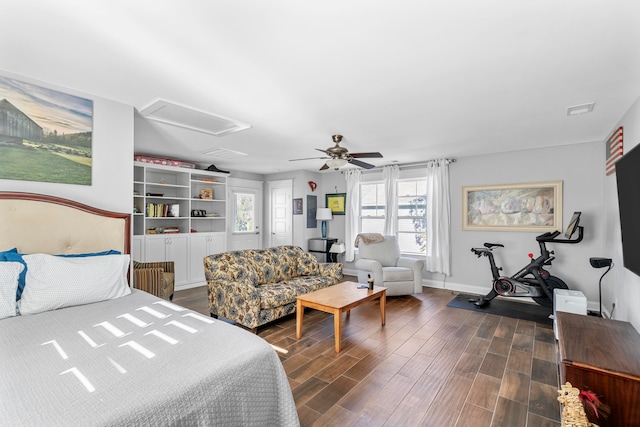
[144,234,189,286]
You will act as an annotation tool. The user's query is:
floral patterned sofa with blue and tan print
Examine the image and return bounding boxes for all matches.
[204,246,342,329]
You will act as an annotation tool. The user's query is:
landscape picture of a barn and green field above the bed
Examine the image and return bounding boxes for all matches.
[0,76,93,185]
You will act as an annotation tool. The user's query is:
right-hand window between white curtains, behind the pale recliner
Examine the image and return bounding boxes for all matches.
[397,179,427,254]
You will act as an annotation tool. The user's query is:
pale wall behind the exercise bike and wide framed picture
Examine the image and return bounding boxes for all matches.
[440,142,605,309]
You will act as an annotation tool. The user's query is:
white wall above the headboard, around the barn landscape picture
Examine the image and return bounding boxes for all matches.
[0,71,134,216]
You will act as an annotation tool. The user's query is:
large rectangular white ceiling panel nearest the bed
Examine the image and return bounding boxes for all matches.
[140,99,251,136]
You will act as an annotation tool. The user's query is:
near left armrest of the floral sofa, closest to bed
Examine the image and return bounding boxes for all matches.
[207,280,260,328]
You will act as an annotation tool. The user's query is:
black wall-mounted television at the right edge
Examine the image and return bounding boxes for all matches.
[616,142,640,276]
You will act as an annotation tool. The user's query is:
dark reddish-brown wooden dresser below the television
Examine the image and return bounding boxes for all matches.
[556,312,640,427]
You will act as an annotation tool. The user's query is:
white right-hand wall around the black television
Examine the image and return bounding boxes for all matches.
[596,98,640,331]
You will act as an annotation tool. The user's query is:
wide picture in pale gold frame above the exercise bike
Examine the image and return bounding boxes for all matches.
[462,181,562,232]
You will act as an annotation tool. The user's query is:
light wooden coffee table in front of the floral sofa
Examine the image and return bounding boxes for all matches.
[296,282,387,353]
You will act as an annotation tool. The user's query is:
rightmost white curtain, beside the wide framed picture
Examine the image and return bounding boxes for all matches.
[426,159,451,276]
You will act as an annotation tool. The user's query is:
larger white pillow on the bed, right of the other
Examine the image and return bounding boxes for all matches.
[19,254,131,314]
